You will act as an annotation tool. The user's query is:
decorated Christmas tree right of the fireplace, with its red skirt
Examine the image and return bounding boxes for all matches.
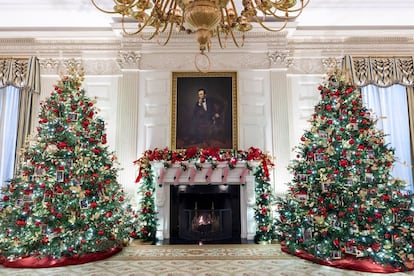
[276,70,414,272]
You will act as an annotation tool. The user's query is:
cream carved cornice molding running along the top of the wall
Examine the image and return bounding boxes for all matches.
[0,30,414,75]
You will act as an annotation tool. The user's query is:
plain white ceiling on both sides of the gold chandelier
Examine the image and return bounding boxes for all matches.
[0,0,414,31]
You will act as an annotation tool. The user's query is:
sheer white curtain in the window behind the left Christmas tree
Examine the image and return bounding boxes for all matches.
[0,86,20,190]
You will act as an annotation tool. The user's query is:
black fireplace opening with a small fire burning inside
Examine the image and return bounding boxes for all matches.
[170,185,241,244]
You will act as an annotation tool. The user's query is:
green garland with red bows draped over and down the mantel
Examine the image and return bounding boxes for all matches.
[134,147,274,243]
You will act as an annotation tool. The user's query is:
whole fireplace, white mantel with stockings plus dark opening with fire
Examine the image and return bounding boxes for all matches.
[151,161,256,243]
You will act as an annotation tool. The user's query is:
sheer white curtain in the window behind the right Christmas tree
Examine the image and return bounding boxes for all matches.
[361,85,414,192]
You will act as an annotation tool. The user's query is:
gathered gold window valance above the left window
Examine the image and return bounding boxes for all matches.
[0,57,40,93]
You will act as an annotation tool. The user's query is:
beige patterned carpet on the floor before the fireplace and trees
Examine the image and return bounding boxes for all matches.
[0,241,414,276]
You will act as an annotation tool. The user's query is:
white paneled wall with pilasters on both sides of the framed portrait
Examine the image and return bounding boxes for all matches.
[37,56,336,204]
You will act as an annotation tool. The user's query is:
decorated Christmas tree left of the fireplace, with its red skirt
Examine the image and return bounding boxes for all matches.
[0,66,134,267]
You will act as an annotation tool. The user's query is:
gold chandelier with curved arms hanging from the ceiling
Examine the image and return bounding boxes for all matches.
[91,0,310,70]
